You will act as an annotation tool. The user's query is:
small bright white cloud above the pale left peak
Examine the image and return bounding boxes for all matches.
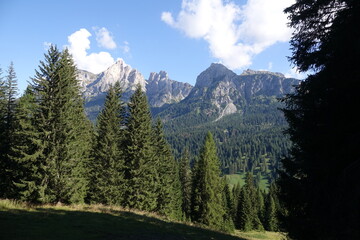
[66,28,115,74]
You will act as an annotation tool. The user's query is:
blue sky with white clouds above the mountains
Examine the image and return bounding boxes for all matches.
[0,0,303,92]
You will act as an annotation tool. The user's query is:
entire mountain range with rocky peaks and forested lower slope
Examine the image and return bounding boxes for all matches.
[78,59,300,180]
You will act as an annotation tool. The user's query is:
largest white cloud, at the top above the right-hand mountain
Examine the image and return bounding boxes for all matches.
[161,0,294,69]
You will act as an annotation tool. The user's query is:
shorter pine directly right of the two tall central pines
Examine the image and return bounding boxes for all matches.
[153,119,182,220]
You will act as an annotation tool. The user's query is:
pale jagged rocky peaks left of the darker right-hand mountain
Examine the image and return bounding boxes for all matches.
[77,59,192,120]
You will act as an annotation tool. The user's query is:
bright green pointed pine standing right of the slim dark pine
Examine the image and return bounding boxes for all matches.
[191,132,228,231]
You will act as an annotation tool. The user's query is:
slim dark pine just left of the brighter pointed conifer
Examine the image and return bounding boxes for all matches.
[179,149,191,219]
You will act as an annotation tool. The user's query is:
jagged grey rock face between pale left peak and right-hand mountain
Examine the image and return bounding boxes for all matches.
[146,71,193,107]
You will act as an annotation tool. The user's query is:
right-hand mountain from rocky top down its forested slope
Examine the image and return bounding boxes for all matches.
[154,64,299,181]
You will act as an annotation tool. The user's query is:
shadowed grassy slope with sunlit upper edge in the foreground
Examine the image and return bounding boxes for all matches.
[0,200,280,240]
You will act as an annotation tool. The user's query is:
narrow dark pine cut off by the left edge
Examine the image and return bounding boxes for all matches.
[0,62,17,198]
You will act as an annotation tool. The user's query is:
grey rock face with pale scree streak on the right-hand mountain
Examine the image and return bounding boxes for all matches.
[184,63,299,120]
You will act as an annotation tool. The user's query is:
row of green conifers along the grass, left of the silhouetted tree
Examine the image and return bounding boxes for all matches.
[0,46,278,232]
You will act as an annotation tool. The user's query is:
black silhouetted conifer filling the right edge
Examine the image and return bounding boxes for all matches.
[280,0,360,239]
